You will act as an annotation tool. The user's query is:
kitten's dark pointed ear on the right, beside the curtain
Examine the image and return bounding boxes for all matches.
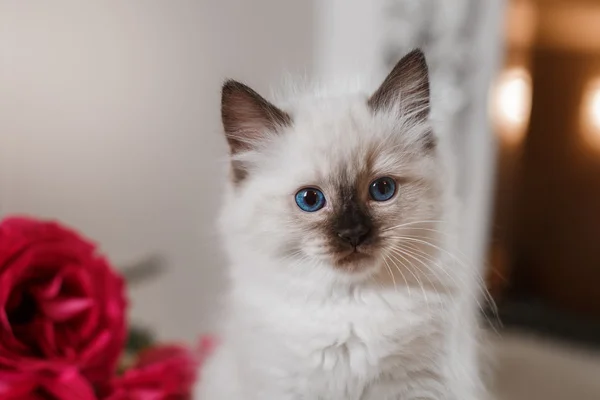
[368,49,429,120]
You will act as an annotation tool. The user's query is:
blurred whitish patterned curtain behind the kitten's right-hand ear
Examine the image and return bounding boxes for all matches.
[381,0,505,265]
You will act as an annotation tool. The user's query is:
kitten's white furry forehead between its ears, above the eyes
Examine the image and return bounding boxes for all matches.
[273,102,419,186]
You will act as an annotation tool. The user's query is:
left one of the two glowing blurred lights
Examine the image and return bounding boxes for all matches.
[491,67,532,145]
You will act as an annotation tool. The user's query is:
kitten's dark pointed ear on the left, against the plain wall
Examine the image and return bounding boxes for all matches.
[221,80,292,155]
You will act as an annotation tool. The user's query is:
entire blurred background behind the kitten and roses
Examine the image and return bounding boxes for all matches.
[0,0,600,400]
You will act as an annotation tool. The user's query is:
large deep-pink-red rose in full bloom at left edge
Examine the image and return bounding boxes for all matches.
[0,218,126,400]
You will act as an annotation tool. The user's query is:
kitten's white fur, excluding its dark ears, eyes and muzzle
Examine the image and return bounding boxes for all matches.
[195,79,483,400]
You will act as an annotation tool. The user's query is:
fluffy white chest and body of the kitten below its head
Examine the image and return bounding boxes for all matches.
[198,272,468,400]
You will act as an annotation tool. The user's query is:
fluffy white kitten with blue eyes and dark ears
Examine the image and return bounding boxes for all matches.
[196,50,483,400]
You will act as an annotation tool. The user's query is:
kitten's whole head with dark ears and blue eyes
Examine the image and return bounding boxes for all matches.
[222,50,443,282]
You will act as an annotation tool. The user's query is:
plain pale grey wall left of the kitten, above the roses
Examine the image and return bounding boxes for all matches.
[0,0,313,338]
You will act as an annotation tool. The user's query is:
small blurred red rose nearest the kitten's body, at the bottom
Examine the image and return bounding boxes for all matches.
[106,345,199,400]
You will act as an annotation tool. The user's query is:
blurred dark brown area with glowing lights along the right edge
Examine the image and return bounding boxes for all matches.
[487,0,600,399]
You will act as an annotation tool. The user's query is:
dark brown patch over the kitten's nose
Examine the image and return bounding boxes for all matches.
[334,189,373,247]
